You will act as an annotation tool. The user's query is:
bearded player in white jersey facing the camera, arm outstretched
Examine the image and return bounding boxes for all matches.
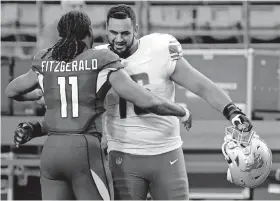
[12,4,252,200]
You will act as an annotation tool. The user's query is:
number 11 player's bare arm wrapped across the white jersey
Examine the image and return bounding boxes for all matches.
[109,69,189,117]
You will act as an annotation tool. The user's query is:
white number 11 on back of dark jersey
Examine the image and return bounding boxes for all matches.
[57,76,79,118]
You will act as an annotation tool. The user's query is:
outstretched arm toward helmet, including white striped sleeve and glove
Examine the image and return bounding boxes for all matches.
[163,34,252,131]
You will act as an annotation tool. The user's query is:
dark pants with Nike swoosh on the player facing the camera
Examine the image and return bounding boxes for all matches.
[109,148,189,200]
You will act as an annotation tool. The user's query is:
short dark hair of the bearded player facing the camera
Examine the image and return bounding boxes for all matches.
[107,4,136,27]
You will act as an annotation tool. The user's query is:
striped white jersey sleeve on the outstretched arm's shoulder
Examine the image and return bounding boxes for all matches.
[165,34,183,76]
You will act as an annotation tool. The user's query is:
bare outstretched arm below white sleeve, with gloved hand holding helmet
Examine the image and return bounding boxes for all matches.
[170,52,252,130]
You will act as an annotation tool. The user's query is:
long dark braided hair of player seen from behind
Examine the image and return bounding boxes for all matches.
[49,11,91,62]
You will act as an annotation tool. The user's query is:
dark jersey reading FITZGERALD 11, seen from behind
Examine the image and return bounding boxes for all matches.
[32,49,122,133]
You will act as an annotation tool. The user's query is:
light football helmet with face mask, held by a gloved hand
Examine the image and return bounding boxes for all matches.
[222,126,272,188]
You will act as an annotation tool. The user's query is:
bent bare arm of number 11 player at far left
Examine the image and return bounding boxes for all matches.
[5,70,42,101]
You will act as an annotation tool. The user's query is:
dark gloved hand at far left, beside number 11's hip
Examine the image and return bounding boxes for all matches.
[14,122,33,148]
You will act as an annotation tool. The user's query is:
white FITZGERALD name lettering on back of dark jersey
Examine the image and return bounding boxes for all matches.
[41,59,98,72]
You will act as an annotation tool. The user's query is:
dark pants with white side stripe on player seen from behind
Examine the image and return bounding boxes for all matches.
[41,134,113,200]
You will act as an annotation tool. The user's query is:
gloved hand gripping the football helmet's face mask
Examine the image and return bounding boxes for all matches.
[230,114,253,132]
